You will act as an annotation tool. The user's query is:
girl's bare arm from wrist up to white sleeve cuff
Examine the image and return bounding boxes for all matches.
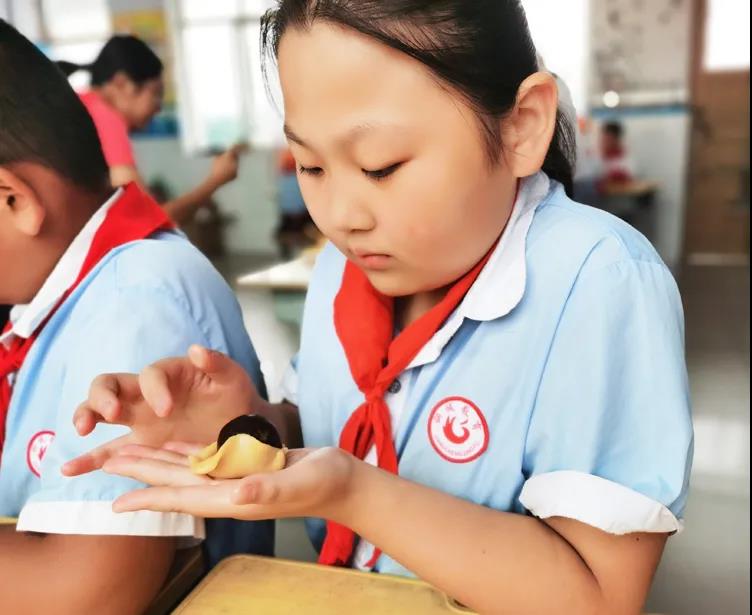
[338,461,666,615]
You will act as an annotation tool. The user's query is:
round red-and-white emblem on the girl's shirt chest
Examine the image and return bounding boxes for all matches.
[428,397,488,463]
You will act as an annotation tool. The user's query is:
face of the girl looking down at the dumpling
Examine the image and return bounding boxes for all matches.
[279,23,516,296]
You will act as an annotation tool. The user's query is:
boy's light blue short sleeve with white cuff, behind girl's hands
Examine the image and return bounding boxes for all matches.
[18,288,206,538]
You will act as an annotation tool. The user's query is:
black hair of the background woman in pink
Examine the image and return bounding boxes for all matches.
[57,35,163,86]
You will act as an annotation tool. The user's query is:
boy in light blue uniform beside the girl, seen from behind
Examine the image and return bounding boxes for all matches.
[0,20,273,613]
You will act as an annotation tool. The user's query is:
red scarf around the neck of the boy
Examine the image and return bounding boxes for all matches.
[0,183,174,462]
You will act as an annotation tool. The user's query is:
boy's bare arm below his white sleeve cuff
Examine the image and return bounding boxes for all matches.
[0,527,175,615]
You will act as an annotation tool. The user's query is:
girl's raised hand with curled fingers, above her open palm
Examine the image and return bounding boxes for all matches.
[62,346,263,476]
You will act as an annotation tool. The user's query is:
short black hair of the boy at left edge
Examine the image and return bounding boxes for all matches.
[0,19,109,192]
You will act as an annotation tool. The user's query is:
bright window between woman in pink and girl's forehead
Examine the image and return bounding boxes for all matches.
[169,0,283,152]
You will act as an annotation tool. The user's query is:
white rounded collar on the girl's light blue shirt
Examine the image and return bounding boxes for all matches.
[408,171,551,369]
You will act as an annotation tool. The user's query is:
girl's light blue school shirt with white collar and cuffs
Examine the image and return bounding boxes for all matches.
[286,173,693,574]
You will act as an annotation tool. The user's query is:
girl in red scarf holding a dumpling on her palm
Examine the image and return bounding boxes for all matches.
[64,0,692,614]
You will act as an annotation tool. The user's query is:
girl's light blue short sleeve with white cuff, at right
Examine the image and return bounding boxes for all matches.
[520,260,693,534]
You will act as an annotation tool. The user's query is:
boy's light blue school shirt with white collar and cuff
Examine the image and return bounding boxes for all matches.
[0,197,273,554]
